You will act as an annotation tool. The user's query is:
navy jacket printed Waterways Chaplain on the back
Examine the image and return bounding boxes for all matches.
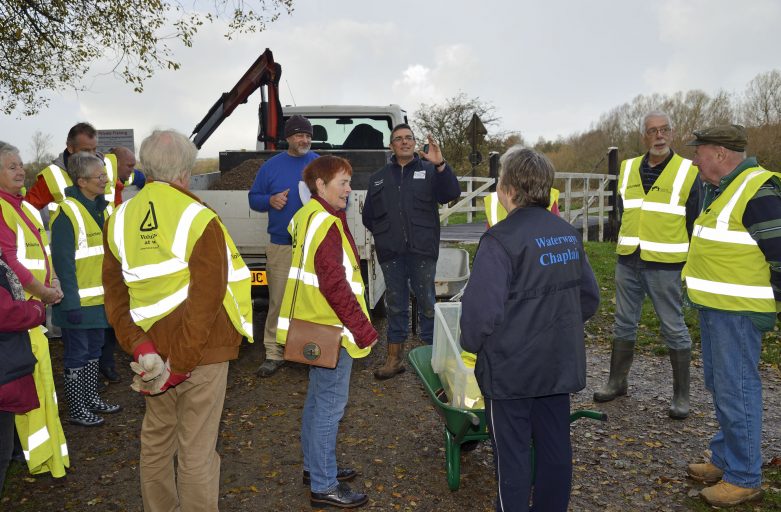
[460,207,599,400]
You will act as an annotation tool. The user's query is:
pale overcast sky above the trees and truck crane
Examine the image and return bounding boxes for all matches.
[0,0,781,159]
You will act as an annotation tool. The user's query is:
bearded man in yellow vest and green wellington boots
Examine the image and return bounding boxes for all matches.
[594,111,702,419]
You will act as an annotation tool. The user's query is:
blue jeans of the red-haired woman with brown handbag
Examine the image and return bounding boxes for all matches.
[301,347,353,492]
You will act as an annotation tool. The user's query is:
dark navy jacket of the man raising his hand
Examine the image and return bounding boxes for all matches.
[362,155,461,263]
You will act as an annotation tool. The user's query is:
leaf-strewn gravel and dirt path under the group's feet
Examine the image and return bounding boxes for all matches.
[0,330,781,512]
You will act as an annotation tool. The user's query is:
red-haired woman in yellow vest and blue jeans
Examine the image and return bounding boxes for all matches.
[277,156,377,508]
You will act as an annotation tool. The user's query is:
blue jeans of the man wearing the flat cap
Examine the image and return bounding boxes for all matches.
[700,309,762,487]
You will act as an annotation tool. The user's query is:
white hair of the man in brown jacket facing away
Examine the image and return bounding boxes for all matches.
[139,130,198,183]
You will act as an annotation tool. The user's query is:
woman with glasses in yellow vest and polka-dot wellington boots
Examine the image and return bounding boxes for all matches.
[51,152,120,427]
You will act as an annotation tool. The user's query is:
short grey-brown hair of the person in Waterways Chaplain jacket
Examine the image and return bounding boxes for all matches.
[499,145,556,208]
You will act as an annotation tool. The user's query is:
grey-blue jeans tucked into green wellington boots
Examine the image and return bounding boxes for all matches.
[613,263,692,350]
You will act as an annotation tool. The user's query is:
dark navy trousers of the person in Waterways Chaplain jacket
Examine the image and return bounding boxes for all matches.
[485,394,572,512]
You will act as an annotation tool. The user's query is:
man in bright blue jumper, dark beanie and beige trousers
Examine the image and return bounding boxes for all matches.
[249,115,319,377]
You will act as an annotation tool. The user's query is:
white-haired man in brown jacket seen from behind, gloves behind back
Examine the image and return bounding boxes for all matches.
[103,131,252,511]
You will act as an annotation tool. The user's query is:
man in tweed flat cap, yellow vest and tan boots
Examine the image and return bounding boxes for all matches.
[682,124,781,507]
